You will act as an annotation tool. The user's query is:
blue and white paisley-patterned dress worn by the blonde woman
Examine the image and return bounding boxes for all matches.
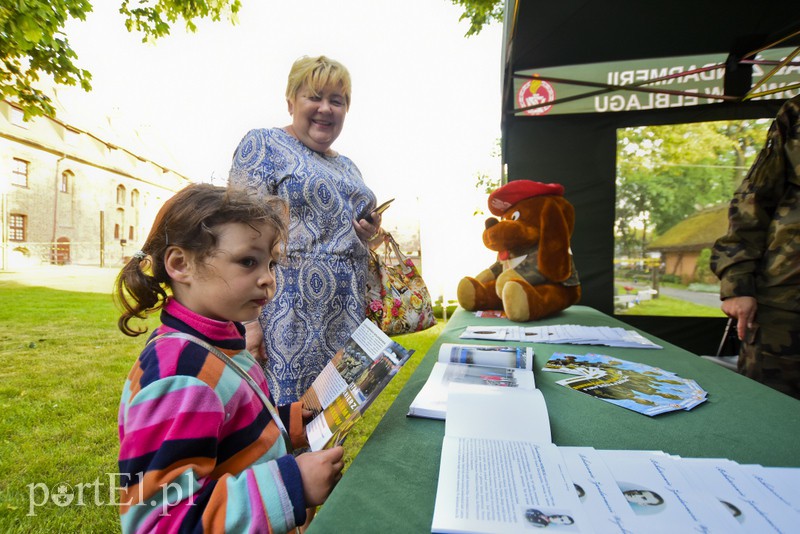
[230,128,375,404]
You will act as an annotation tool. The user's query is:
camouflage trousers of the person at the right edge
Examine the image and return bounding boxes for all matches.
[738,304,800,399]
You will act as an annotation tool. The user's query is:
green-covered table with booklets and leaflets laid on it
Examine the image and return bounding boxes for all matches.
[309,306,800,534]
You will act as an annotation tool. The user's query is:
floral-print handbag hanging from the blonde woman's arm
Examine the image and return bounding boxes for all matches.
[367,233,436,336]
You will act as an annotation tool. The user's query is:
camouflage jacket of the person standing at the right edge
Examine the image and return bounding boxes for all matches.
[711,95,800,312]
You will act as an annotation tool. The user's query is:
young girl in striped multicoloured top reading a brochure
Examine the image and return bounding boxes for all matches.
[115,184,343,532]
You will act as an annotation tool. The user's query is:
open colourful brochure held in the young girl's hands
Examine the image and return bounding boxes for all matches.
[301,319,414,451]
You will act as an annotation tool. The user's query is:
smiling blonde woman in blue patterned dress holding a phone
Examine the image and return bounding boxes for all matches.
[230,56,382,404]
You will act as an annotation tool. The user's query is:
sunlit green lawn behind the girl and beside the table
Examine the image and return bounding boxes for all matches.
[0,281,443,533]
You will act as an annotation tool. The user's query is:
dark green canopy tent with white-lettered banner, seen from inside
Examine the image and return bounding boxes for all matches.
[502,0,800,354]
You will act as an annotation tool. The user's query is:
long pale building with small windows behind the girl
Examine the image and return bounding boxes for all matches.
[0,101,190,270]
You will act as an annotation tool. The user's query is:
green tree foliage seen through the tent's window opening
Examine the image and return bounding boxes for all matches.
[615,120,770,256]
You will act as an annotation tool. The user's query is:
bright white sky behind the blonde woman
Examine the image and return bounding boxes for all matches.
[59,0,502,299]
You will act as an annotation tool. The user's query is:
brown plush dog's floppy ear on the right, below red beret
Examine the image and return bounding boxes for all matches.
[538,198,575,282]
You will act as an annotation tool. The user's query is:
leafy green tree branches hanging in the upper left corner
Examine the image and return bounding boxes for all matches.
[0,0,241,119]
